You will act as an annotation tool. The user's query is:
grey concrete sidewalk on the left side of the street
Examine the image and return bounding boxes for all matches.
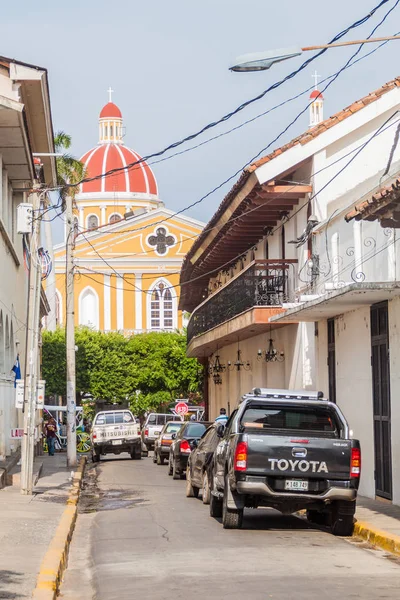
[0,453,71,600]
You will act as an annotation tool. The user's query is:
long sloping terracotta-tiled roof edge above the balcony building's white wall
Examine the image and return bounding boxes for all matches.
[247,77,400,172]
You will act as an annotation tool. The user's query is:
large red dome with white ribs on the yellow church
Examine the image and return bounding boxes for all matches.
[80,144,158,196]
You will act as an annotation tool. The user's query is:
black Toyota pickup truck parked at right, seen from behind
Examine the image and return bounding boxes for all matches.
[210,388,361,536]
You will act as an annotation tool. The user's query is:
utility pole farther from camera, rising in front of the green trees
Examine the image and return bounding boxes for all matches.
[65,195,77,467]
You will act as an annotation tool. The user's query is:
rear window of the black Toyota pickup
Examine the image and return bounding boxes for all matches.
[240,405,339,437]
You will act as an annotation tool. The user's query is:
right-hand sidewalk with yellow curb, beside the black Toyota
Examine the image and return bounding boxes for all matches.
[354,496,400,555]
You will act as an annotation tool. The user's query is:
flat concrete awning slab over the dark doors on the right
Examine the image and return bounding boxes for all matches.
[270,282,400,323]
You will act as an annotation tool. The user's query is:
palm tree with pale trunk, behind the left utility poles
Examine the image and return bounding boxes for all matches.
[44,131,86,331]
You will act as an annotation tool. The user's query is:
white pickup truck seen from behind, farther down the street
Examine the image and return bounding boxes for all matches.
[91,410,142,462]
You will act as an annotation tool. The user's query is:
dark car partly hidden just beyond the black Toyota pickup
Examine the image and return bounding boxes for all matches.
[186,424,220,504]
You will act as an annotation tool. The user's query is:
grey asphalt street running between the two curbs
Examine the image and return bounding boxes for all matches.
[61,455,400,600]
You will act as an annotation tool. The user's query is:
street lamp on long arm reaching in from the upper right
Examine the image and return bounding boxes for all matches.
[229,35,400,73]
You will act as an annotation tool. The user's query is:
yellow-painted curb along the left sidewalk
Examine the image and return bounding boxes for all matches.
[32,456,87,600]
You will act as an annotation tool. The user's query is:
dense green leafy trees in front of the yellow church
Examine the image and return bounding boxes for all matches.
[43,327,200,414]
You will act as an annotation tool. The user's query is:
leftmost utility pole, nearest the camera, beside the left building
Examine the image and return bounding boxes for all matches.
[21,185,42,495]
